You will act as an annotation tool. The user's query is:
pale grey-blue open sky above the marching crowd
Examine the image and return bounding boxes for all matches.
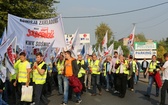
[55,0,168,44]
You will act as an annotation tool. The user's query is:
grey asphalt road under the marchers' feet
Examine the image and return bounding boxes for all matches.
[48,82,168,105]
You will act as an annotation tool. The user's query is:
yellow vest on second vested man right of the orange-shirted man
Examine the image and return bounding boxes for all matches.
[90,60,100,74]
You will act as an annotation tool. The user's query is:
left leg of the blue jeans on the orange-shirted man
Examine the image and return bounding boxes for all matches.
[63,77,69,103]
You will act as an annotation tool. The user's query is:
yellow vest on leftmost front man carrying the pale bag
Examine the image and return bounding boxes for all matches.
[18,61,29,83]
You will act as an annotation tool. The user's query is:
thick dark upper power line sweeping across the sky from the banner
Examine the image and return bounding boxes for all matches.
[62,2,168,18]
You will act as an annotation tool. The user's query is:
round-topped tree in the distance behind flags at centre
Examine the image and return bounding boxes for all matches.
[95,23,113,49]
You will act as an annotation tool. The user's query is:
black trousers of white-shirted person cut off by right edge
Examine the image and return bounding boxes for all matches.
[160,80,168,105]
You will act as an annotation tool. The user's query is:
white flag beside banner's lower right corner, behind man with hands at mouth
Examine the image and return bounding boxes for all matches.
[43,41,54,64]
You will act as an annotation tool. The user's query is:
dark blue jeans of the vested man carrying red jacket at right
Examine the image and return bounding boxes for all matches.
[147,75,159,95]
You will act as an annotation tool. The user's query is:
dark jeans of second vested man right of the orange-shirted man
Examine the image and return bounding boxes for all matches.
[92,74,101,94]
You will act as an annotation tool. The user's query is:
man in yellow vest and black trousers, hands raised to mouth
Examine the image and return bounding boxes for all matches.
[33,52,48,105]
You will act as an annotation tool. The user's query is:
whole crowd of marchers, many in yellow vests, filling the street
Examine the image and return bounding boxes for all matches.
[0,51,168,105]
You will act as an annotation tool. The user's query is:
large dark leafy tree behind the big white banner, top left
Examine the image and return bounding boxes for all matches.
[0,0,56,36]
